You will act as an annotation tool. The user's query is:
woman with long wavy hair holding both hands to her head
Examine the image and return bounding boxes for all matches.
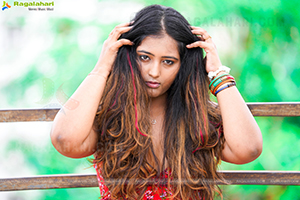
[51,5,262,199]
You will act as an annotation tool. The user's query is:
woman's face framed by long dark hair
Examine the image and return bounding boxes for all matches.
[136,34,180,98]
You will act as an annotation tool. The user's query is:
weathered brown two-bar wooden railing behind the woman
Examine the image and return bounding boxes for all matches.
[0,102,300,191]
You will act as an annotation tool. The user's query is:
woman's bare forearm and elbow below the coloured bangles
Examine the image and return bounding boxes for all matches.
[217,80,263,164]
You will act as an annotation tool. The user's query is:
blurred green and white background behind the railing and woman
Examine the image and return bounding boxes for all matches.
[0,0,300,200]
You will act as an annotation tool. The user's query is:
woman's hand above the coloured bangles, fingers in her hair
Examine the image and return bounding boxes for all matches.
[186,26,222,73]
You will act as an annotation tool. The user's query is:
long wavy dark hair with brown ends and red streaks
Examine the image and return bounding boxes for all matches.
[93,5,224,200]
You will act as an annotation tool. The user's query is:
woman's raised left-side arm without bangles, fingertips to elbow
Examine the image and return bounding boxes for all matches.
[50,23,132,158]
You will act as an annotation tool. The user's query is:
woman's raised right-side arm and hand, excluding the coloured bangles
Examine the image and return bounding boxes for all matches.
[187,27,262,164]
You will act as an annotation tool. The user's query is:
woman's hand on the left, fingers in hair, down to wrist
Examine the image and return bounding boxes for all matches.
[93,22,133,76]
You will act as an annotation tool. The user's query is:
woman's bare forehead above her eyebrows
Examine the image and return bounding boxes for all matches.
[137,33,179,57]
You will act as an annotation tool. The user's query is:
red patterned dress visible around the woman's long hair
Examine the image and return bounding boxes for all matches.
[94,164,172,200]
